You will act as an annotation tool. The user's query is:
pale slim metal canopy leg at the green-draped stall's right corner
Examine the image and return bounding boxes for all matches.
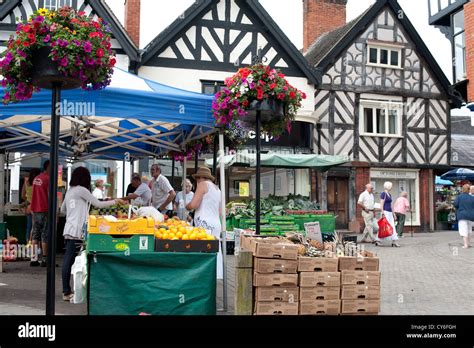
[219,128,227,312]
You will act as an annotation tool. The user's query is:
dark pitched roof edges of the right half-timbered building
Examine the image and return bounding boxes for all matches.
[305,0,452,100]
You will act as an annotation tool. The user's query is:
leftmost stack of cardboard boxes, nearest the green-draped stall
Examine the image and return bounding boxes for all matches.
[250,239,299,315]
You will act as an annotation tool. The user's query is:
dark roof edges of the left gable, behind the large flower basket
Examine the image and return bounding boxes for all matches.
[0,0,139,61]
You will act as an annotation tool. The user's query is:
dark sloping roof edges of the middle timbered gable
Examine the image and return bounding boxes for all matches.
[140,0,319,84]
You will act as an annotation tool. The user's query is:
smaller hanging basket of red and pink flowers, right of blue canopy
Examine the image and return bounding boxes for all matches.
[212,63,306,136]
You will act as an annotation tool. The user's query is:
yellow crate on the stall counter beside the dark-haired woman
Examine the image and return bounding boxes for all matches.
[87,215,155,235]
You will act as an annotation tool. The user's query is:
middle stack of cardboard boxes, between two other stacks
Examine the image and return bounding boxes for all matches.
[298,257,341,315]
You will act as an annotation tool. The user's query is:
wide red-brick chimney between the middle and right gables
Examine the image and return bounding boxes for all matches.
[303,0,347,52]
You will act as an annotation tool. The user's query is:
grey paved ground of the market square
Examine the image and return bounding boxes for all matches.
[0,231,474,315]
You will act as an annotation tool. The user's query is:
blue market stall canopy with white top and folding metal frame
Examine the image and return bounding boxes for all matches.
[0,68,214,159]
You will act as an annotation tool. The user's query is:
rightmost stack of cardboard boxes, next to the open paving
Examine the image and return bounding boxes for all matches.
[339,251,380,315]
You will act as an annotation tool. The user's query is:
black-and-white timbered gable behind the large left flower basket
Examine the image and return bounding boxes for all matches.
[0,0,139,71]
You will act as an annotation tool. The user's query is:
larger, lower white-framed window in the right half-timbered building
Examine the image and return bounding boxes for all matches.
[360,100,402,137]
